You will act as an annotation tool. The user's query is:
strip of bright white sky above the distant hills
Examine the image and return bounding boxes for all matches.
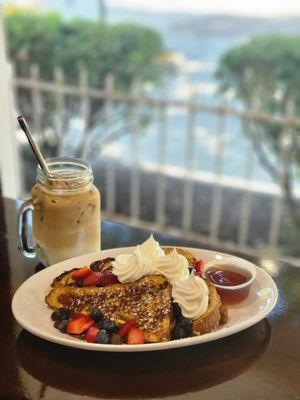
[107,0,300,16]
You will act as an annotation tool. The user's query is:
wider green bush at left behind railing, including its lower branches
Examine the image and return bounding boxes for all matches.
[5,11,164,156]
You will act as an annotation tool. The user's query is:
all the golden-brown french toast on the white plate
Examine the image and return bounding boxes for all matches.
[45,247,227,342]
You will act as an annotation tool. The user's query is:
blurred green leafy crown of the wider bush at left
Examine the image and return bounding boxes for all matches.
[5,12,164,155]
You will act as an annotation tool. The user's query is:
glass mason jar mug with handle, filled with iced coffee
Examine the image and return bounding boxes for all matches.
[18,158,100,265]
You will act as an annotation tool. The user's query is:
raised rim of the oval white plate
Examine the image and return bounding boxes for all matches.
[11,246,278,353]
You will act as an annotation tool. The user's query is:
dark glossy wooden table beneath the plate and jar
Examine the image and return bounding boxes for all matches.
[0,197,300,400]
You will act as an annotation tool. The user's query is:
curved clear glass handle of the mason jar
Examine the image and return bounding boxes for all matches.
[18,199,36,258]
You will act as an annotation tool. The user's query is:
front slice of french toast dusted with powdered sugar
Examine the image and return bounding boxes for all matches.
[45,275,173,342]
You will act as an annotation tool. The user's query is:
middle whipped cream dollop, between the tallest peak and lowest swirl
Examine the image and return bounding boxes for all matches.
[153,249,190,283]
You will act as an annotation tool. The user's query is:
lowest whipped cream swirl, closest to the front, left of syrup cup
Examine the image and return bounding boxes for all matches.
[172,271,209,319]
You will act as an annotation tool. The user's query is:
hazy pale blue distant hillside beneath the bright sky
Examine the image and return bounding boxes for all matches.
[40,0,300,37]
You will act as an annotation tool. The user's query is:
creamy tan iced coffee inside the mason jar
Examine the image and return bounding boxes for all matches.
[31,184,100,264]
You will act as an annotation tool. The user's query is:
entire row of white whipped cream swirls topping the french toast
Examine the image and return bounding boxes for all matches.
[112,235,209,319]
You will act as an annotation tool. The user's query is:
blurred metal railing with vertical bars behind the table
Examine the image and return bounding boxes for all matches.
[12,66,300,260]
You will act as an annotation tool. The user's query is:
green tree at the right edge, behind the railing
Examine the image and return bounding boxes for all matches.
[216,35,300,230]
